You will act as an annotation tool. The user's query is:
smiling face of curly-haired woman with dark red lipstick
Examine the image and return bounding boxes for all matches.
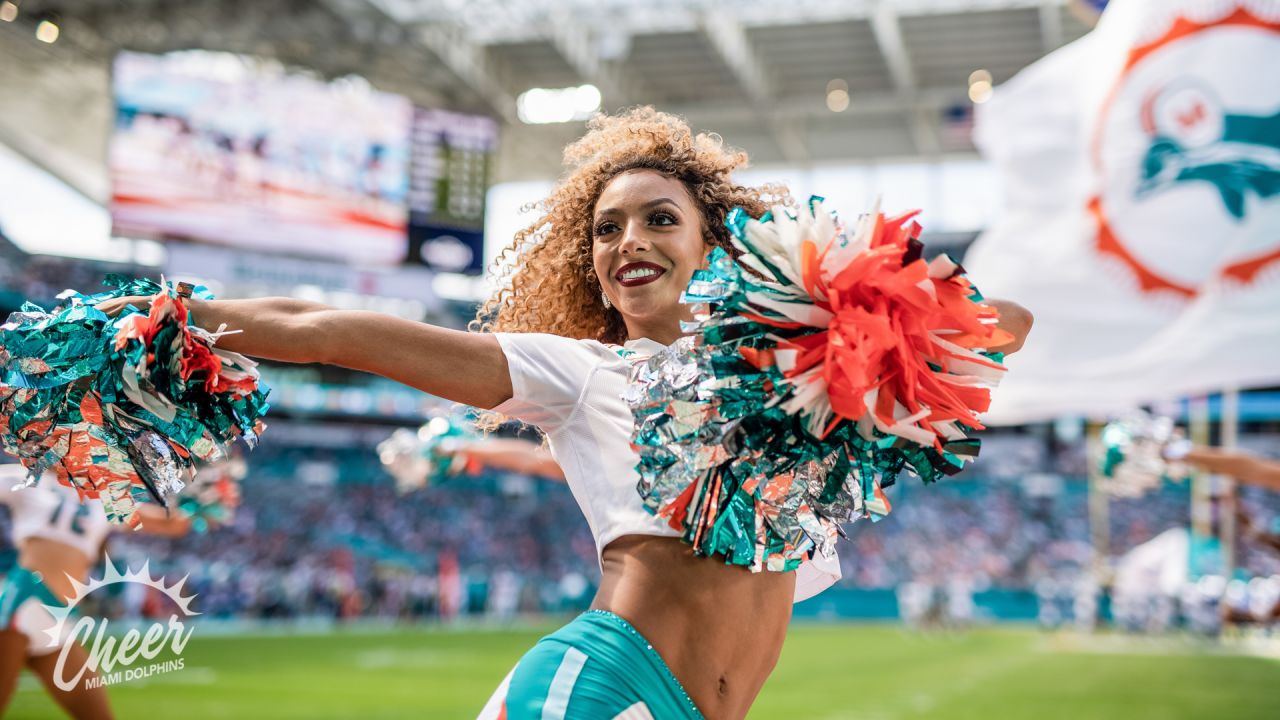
[591,170,710,343]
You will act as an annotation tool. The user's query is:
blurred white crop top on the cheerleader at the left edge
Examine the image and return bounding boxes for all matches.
[0,465,111,561]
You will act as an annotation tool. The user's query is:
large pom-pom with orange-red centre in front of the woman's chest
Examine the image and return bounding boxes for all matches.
[627,197,1011,571]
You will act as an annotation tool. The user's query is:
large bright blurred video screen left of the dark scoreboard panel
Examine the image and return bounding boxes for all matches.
[110,51,413,265]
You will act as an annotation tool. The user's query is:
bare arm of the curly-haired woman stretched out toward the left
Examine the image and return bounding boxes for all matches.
[99,297,512,409]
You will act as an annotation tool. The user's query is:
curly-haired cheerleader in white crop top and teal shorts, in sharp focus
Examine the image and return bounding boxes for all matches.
[101,108,1030,720]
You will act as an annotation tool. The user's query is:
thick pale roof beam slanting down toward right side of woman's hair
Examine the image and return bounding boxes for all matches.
[701,8,809,164]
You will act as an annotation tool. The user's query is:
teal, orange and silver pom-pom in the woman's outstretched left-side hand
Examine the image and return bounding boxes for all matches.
[0,275,268,525]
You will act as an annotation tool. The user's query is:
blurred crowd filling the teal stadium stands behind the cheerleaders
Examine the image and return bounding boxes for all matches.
[0,434,1280,623]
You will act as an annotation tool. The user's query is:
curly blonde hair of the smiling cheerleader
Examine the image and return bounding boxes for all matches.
[471,106,790,342]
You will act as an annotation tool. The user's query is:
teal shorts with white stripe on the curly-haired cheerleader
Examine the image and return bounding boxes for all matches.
[497,610,703,720]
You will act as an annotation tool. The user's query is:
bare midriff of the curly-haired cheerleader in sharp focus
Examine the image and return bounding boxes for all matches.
[591,536,795,720]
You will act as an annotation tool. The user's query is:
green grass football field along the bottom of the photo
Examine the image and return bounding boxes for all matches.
[8,624,1280,720]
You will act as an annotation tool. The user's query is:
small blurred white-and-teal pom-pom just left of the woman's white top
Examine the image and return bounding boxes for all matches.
[378,415,479,493]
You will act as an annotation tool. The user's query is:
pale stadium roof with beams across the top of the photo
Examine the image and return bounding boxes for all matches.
[0,0,1087,197]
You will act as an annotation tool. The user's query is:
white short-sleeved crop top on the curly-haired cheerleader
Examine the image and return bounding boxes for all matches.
[494,333,840,602]
